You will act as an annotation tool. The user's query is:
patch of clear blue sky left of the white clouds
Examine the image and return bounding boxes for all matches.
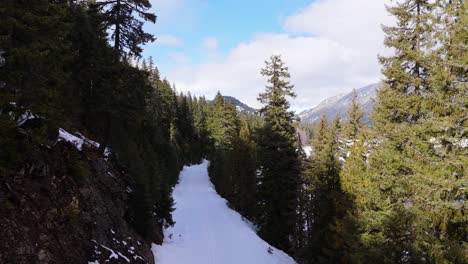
[144,0,311,70]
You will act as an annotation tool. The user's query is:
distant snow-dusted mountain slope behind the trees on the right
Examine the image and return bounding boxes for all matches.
[298,83,380,124]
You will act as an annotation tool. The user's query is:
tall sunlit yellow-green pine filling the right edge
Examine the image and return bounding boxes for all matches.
[356,0,466,263]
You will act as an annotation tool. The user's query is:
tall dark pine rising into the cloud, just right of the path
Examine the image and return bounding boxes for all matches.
[257,56,301,251]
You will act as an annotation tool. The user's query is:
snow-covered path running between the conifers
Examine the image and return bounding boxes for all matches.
[153,161,295,264]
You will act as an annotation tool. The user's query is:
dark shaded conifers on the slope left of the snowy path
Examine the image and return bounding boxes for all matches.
[0,0,206,236]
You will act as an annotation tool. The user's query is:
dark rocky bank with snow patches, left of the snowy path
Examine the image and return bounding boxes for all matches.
[0,139,162,264]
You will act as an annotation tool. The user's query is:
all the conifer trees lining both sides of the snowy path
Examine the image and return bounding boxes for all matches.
[0,0,468,263]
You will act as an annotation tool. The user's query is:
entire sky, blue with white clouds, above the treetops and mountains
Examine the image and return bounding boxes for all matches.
[143,0,392,111]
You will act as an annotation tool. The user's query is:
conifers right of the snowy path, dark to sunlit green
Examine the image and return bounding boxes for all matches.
[210,0,468,263]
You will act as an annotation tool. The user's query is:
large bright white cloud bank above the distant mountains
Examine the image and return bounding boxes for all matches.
[168,0,389,110]
